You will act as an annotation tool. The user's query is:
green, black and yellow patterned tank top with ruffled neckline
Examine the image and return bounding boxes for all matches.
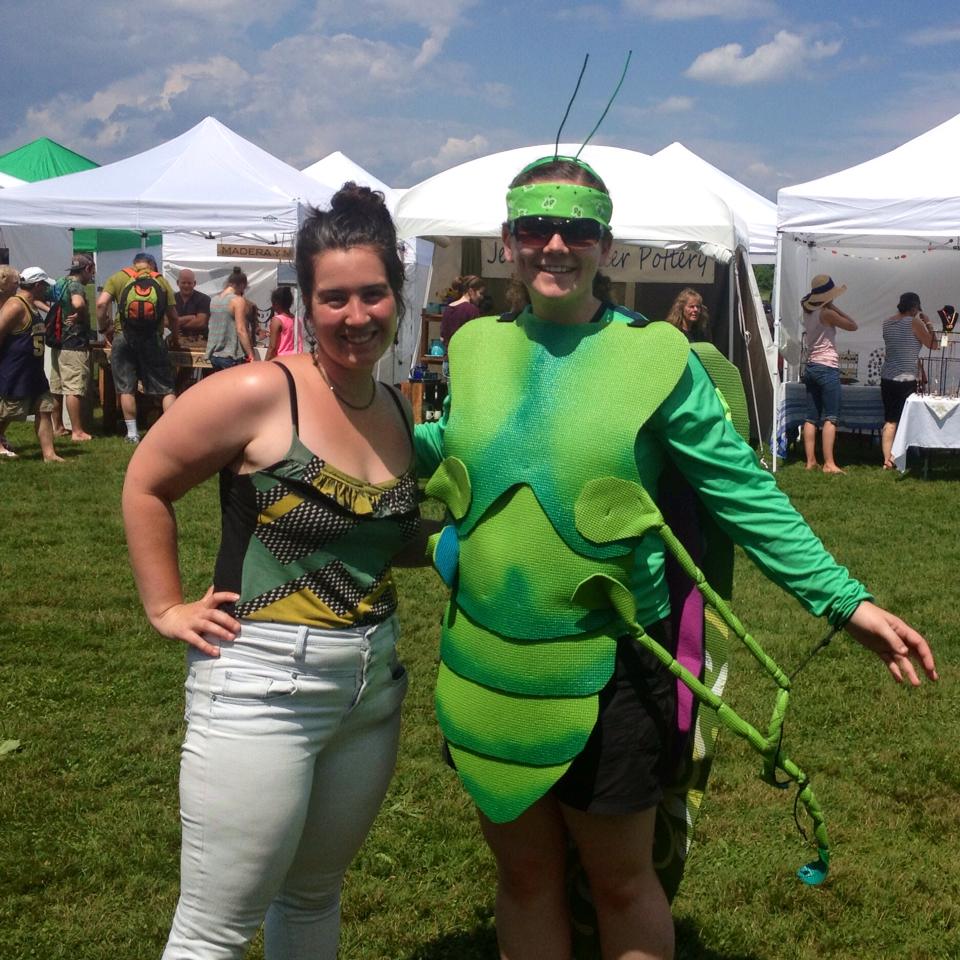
[214,363,420,629]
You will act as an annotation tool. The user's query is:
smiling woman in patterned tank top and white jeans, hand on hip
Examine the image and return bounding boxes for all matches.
[123,183,432,960]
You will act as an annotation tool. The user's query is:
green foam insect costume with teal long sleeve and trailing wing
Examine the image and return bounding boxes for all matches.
[417,305,869,894]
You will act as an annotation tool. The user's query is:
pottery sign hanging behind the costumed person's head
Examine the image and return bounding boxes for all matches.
[480,239,715,283]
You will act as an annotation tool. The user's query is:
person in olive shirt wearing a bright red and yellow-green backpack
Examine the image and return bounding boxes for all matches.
[97,253,179,443]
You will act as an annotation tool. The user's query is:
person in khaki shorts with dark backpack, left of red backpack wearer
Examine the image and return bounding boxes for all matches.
[45,253,96,441]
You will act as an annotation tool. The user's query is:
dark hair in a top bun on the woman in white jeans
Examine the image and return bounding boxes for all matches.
[295,180,406,323]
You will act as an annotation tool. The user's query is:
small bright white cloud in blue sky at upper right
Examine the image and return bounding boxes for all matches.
[685,30,841,86]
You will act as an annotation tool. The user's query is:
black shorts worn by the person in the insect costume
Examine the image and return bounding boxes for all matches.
[552,620,677,814]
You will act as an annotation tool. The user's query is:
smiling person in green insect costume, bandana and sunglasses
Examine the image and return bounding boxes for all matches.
[416,157,936,960]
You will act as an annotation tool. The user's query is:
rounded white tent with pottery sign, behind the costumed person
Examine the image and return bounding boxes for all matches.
[395,144,776,437]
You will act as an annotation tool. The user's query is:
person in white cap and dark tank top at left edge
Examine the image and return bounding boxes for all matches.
[0,267,63,462]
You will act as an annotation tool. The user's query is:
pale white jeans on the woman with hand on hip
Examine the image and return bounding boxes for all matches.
[163,618,407,960]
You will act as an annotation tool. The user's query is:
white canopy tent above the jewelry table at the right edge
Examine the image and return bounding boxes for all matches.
[774,115,960,370]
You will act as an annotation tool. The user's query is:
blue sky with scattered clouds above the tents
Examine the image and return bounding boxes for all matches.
[0,0,960,198]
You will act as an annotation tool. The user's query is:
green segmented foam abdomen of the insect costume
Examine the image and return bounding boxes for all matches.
[436,486,630,823]
